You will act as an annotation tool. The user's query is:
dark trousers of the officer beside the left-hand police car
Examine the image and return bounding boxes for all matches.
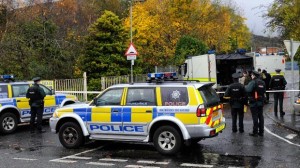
[30,106,44,130]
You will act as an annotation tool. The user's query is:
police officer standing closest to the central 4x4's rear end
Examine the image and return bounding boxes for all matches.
[224,73,247,133]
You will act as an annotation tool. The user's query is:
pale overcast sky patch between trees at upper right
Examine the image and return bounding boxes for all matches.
[232,0,276,37]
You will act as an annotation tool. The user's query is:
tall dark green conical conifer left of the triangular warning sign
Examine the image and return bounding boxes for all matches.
[79,11,129,90]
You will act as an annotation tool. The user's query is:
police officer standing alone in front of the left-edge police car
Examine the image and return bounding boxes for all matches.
[26,77,46,133]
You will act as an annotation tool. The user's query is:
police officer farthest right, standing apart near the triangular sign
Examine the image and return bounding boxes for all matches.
[270,69,287,117]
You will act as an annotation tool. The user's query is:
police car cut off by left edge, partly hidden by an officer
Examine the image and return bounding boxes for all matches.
[0,75,77,134]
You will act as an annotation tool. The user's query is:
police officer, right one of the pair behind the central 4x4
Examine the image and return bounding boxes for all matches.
[246,71,266,137]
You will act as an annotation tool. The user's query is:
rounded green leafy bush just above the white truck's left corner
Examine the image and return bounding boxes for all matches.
[174,36,208,65]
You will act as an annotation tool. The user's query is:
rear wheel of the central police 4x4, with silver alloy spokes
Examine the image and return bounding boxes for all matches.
[153,126,182,155]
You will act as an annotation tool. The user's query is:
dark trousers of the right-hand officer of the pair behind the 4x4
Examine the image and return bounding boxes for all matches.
[250,106,264,134]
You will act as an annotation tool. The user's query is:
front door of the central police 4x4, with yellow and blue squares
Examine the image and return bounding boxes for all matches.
[86,88,124,135]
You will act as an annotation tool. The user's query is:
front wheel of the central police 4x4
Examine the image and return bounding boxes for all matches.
[58,122,84,149]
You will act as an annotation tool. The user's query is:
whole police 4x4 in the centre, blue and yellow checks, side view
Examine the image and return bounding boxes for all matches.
[50,73,225,154]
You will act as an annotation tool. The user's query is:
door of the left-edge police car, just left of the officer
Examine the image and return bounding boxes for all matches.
[11,83,30,120]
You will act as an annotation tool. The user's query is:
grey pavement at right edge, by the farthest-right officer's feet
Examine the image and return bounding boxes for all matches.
[265,95,300,134]
